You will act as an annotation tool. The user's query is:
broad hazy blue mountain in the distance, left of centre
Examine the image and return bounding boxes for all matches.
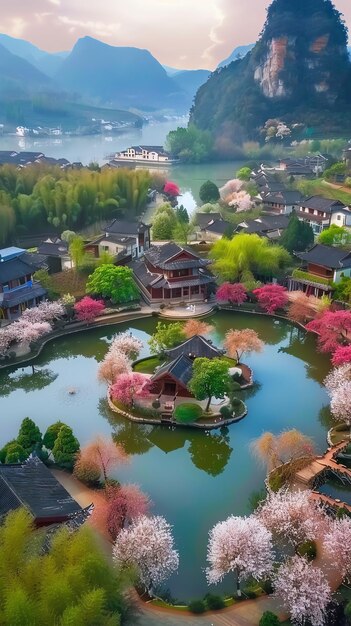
[55,37,189,111]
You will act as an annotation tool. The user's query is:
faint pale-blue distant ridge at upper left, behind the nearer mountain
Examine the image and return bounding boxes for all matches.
[0,33,69,78]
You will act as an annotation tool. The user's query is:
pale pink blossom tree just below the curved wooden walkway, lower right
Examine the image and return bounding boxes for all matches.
[256,489,326,548]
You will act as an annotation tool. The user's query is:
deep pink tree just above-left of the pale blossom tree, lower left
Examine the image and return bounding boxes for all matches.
[90,485,151,541]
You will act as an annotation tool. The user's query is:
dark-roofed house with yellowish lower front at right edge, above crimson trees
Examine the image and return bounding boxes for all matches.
[289,244,351,298]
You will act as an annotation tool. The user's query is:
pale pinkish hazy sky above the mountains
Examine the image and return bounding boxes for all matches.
[0,0,351,69]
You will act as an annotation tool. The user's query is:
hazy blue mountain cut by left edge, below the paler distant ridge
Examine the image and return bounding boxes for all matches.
[0,44,52,98]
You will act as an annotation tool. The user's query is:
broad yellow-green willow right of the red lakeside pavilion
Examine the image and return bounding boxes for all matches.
[210,233,291,283]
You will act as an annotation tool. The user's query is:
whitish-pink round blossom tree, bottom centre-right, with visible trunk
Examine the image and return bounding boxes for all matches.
[207,515,273,596]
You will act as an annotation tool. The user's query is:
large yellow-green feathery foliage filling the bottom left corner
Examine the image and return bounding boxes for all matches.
[0,509,130,626]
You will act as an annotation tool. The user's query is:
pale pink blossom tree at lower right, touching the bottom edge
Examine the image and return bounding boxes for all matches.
[274,556,331,626]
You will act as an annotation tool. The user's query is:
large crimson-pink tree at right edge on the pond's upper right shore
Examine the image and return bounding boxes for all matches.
[306,311,351,353]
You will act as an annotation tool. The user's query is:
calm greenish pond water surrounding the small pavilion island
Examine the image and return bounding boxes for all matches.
[0,311,330,600]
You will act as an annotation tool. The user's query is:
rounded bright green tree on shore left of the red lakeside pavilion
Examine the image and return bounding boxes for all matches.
[86,265,139,304]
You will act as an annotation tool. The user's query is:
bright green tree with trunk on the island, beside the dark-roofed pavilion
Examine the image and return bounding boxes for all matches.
[189,358,230,411]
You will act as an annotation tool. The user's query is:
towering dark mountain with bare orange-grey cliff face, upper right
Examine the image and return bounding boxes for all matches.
[190,0,351,143]
